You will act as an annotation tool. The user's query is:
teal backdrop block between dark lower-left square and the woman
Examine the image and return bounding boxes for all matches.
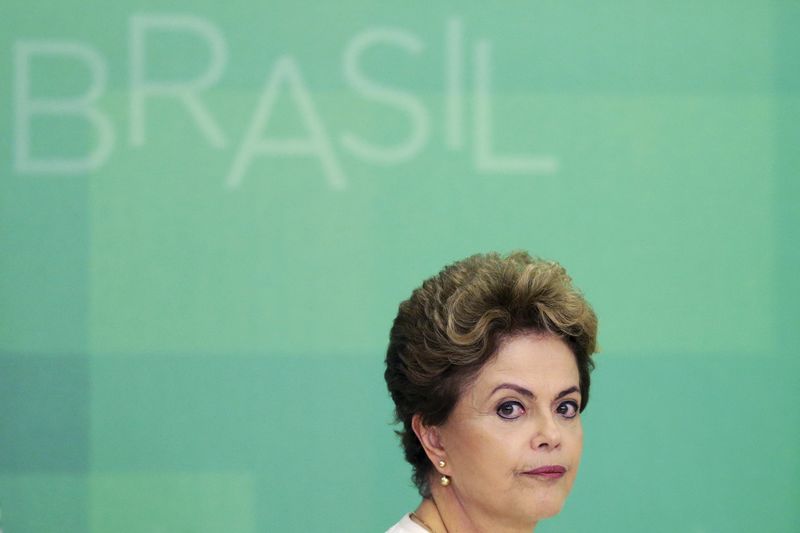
[91,354,414,531]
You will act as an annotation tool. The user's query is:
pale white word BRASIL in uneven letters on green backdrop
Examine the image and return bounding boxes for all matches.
[13,14,557,189]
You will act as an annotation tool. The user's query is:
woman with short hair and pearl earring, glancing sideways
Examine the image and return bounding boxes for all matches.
[385,252,597,533]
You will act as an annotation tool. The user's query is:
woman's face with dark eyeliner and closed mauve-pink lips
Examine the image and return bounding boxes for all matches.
[439,334,583,523]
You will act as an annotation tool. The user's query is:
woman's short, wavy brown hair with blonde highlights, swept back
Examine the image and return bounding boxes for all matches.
[384,251,597,497]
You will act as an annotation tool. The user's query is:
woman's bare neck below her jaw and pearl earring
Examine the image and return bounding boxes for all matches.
[413,485,536,533]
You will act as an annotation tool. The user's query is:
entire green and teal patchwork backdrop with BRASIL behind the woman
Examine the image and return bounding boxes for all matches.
[0,0,800,533]
